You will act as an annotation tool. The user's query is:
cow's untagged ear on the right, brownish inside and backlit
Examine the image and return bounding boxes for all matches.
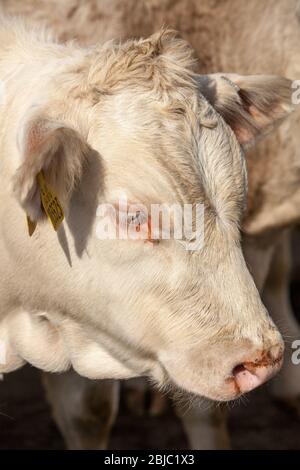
[199,74,294,146]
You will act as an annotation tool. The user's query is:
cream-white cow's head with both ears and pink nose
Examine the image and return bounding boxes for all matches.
[14,32,290,400]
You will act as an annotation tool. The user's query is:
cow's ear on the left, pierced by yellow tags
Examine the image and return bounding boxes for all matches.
[13,116,90,221]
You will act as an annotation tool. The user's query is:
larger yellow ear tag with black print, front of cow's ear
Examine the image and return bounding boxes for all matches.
[37,171,64,231]
